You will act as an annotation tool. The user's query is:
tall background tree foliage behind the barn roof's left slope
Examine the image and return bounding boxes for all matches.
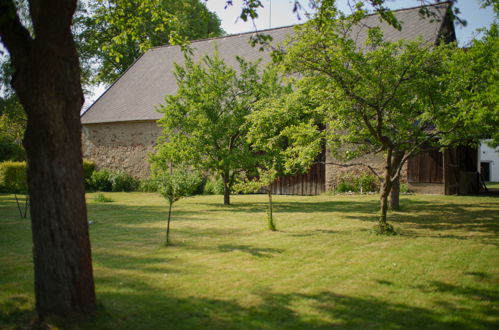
[76,0,223,84]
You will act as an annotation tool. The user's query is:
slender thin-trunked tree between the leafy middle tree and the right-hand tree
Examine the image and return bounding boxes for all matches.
[237,82,323,230]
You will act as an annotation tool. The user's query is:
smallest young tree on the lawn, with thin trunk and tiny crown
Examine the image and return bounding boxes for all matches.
[153,165,201,246]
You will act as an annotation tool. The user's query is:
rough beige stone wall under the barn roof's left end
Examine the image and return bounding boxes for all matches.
[82,121,161,177]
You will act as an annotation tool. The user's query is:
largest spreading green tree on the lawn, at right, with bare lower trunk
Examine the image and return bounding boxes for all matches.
[286,8,466,233]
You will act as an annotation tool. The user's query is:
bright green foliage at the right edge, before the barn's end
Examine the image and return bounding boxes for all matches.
[439,22,499,145]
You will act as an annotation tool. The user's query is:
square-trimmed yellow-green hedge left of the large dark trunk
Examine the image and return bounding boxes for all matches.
[0,161,28,194]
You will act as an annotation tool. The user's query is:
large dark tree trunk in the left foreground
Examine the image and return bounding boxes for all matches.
[0,0,96,318]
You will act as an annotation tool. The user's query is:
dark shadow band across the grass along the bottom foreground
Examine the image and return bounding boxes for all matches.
[5,278,497,329]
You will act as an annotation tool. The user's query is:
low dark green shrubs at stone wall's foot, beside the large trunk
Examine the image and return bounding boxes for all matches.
[89,170,139,191]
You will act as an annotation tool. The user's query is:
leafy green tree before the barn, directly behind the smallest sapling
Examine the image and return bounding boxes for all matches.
[156,54,284,205]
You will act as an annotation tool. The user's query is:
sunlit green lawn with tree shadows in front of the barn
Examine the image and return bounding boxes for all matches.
[0,193,499,329]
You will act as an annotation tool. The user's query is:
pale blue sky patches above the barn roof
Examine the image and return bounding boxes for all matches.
[206,0,493,45]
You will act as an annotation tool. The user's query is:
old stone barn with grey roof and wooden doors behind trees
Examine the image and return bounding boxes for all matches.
[81,3,476,195]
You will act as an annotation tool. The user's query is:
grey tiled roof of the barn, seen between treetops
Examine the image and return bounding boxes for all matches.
[82,3,450,124]
